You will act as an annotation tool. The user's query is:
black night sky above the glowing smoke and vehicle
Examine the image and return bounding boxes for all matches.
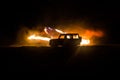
[0,0,120,43]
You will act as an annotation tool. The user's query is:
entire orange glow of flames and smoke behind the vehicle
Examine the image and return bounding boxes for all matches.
[14,21,106,46]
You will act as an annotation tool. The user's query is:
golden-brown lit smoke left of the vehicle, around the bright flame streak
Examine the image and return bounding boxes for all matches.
[11,26,49,47]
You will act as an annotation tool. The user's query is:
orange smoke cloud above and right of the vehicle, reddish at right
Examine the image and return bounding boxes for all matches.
[56,23,105,45]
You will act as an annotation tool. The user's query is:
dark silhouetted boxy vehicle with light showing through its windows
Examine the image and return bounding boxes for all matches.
[49,33,82,47]
